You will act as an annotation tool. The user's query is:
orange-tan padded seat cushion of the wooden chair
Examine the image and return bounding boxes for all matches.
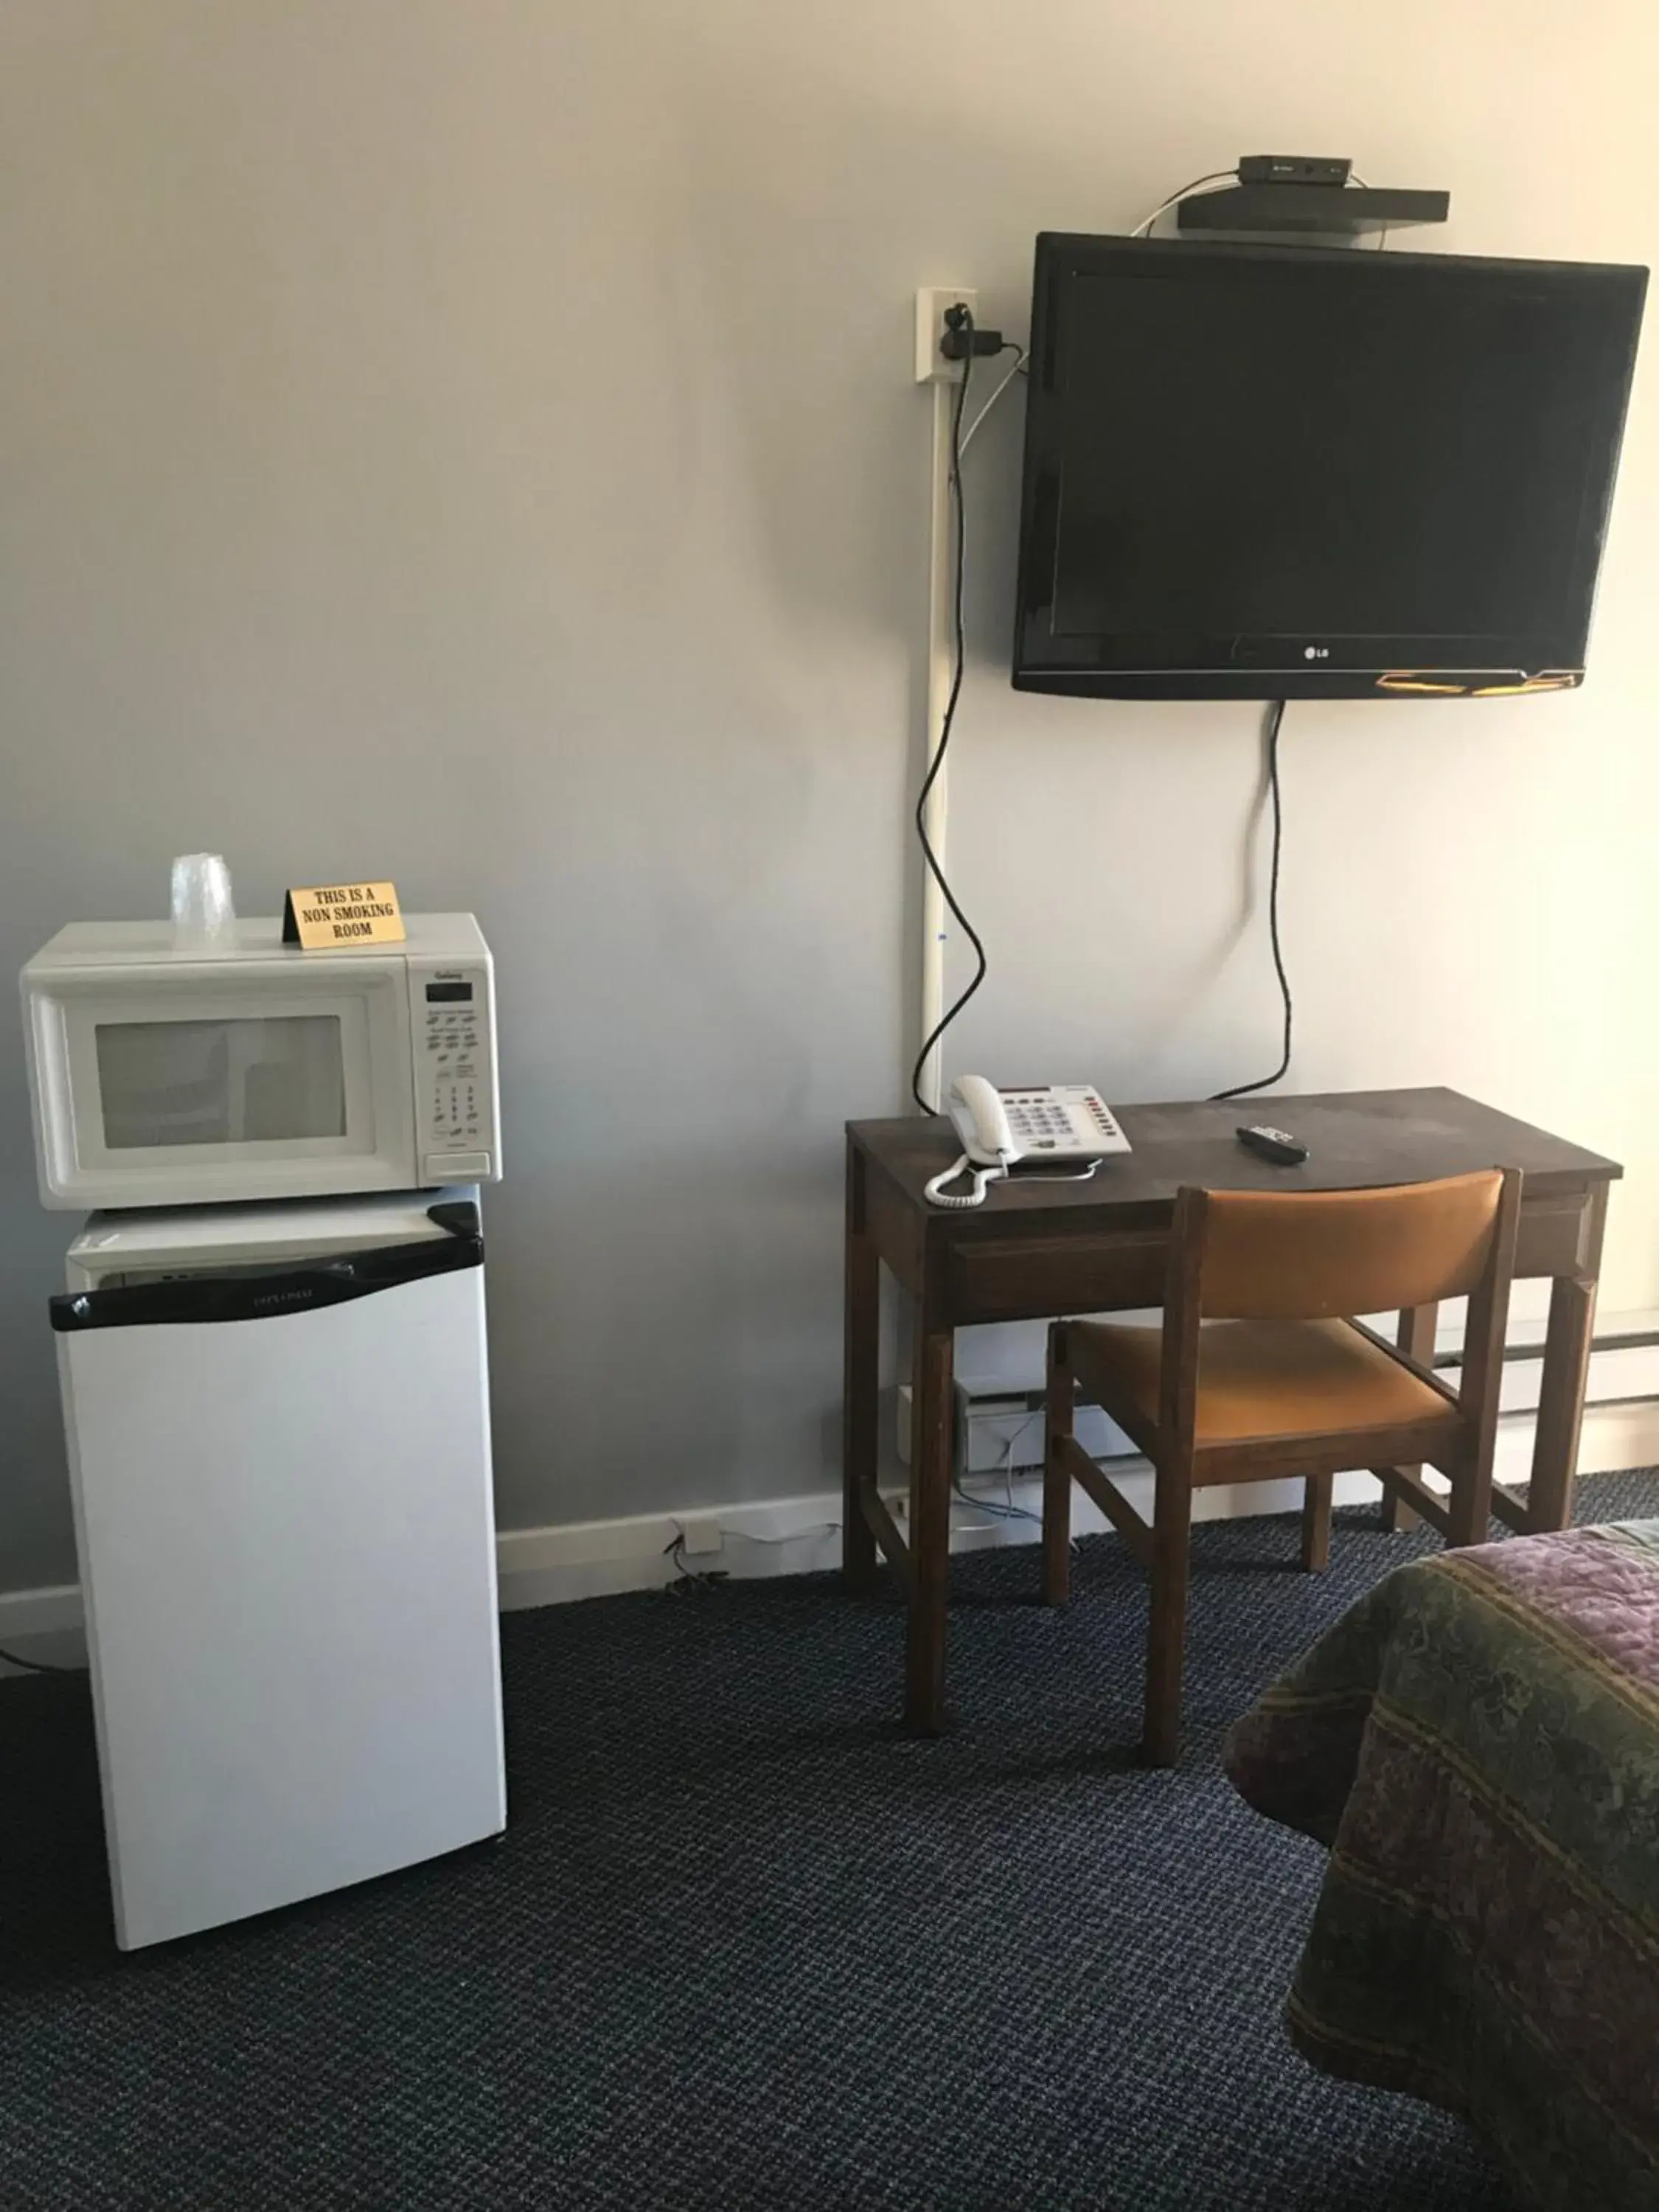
[1071,1321,1455,1444]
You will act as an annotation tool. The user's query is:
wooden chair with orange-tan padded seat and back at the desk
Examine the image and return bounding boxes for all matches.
[1042,1168,1522,1765]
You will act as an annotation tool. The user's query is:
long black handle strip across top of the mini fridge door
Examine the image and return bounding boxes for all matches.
[49,1230,484,1334]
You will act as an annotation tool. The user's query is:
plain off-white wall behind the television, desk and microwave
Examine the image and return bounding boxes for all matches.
[0,0,1659,1586]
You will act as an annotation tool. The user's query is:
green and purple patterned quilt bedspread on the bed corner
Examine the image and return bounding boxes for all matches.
[1228,1522,1659,2212]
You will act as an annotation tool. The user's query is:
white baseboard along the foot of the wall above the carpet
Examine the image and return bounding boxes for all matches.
[0,1400,1659,1672]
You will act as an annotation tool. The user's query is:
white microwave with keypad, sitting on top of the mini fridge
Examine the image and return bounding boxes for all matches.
[22,914,502,1210]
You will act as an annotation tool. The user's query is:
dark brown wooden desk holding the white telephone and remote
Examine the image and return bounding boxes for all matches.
[841,1091,1624,1734]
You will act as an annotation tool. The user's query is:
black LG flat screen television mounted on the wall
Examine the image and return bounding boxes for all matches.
[1013,232,1648,699]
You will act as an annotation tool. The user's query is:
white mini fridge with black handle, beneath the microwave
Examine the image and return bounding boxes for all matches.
[51,1190,507,1949]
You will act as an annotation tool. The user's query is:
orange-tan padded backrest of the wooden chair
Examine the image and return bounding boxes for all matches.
[1192,1168,1504,1321]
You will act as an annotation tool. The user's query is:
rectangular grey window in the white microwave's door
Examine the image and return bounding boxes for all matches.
[97,1013,345,1152]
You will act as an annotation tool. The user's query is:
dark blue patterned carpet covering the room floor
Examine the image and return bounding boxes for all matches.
[0,1475,1659,2212]
